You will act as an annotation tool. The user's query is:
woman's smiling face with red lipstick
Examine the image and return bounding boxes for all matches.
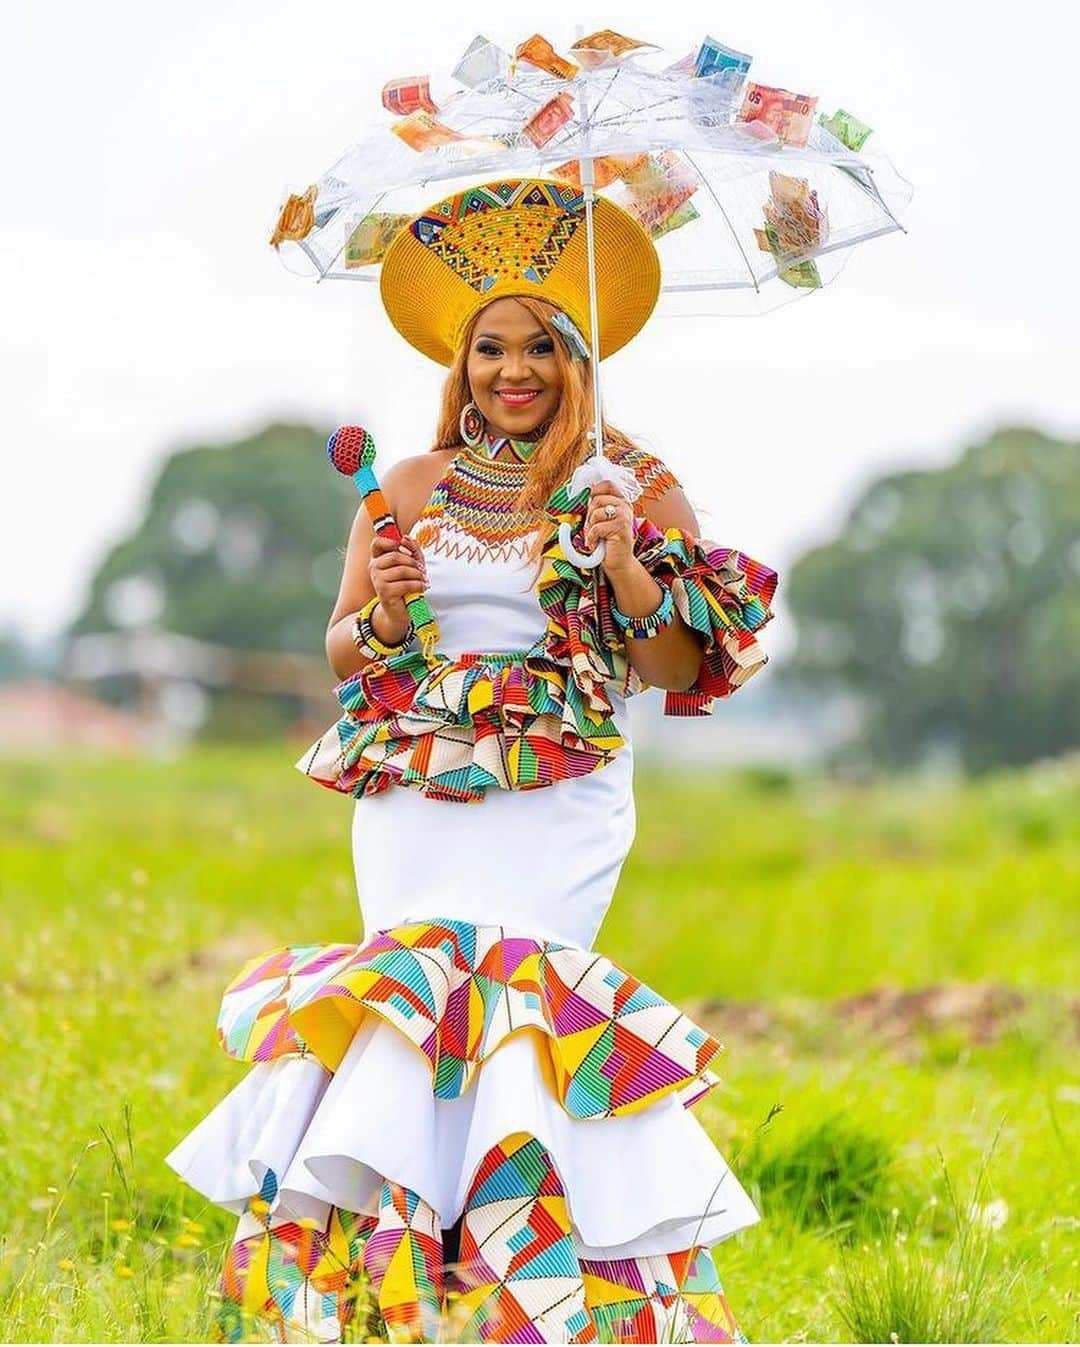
[466,295,563,439]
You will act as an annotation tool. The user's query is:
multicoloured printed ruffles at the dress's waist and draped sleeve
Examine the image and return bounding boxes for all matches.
[296,474,777,803]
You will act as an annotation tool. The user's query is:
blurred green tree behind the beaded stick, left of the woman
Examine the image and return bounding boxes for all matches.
[70,424,357,657]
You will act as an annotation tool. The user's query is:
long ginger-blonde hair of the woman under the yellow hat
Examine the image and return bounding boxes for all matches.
[431,295,636,559]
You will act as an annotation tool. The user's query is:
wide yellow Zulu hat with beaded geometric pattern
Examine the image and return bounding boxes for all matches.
[380,178,660,365]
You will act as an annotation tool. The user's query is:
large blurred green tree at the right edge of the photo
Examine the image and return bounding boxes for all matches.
[778,428,1080,772]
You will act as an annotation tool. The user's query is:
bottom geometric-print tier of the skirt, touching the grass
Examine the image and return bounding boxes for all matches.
[214,1133,746,1343]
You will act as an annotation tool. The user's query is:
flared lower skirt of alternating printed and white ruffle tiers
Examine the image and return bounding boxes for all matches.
[167,917,758,1343]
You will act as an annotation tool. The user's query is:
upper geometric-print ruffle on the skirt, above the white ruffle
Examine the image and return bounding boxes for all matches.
[218,919,723,1118]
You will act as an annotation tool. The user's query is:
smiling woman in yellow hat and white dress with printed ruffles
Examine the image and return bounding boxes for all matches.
[168,179,776,1343]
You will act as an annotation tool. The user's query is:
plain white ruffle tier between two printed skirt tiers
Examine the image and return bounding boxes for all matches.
[166,1016,760,1258]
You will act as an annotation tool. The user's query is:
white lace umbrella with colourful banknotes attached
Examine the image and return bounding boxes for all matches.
[271,30,910,567]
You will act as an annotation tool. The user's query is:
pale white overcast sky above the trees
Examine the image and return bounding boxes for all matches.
[0,0,1080,634]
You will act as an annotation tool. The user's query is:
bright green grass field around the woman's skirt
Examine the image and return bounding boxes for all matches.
[0,752,1080,1342]
